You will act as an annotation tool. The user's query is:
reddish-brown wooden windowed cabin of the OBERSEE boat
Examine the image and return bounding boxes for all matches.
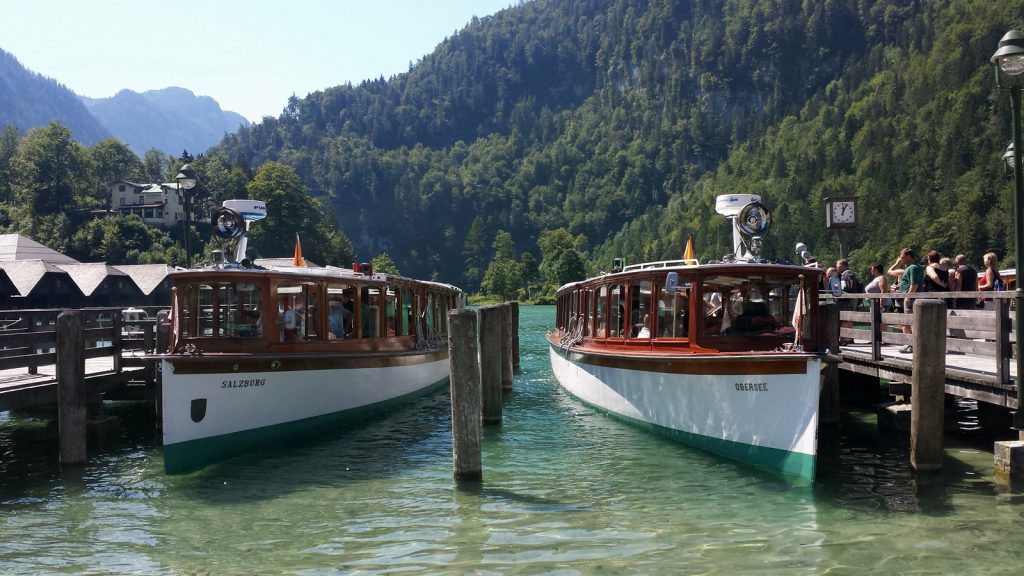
[556,261,821,352]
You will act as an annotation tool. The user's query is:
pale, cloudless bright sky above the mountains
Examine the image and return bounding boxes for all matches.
[0,0,516,122]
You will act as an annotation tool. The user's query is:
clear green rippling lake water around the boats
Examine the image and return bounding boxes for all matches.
[0,306,1024,575]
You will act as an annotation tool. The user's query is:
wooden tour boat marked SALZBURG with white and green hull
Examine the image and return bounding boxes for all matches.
[157,200,465,472]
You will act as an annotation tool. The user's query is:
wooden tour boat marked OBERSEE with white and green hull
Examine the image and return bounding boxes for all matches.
[548,195,824,480]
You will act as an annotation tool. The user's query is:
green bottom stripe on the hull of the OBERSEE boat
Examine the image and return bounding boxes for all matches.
[563,388,816,481]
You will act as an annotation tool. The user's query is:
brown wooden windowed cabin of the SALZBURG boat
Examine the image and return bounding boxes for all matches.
[169,266,462,354]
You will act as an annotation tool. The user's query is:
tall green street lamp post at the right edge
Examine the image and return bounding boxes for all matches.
[990,30,1024,430]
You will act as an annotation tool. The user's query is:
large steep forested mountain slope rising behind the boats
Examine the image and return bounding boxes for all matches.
[211,0,1024,290]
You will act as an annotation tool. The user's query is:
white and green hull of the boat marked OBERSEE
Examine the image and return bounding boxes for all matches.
[550,343,821,480]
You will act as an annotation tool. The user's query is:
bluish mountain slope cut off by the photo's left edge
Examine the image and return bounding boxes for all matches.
[0,49,111,146]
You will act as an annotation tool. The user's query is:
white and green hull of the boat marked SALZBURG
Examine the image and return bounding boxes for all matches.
[161,351,449,474]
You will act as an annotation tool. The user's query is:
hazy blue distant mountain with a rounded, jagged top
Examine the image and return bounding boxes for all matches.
[81,87,249,156]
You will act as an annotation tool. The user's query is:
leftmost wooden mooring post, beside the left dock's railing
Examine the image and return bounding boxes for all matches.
[56,311,86,464]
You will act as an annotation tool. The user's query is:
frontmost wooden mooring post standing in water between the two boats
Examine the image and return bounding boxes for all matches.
[449,310,483,481]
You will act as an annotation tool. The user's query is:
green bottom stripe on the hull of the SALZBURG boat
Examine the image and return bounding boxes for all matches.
[164,378,449,474]
